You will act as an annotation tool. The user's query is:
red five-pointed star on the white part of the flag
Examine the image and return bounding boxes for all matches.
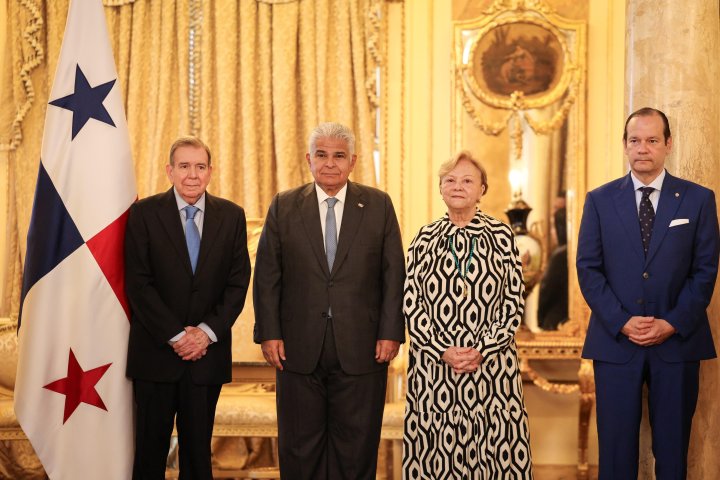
[43,349,112,424]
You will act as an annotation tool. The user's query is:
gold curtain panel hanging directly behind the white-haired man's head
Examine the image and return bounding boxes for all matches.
[195,0,376,217]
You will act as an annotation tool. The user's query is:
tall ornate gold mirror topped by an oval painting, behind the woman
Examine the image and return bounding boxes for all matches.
[453,0,587,344]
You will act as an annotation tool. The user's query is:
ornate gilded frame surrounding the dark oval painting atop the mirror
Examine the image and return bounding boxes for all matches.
[453,0,587,159]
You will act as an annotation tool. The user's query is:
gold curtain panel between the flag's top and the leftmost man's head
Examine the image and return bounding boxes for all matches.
[105,0,190,198]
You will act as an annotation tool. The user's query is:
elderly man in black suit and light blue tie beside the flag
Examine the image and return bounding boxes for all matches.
[125,137,250,480]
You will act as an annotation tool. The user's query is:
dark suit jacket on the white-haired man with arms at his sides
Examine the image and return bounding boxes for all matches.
[253,182,405,375]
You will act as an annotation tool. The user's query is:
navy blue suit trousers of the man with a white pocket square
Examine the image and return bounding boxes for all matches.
[593,347,700,480]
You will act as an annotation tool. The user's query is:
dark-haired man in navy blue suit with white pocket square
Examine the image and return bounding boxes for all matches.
[577,108,720,480]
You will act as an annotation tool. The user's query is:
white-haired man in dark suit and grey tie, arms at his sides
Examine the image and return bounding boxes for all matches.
[253,123,405,480]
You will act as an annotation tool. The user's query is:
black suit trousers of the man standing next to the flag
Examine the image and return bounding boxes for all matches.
[133,369,222,480]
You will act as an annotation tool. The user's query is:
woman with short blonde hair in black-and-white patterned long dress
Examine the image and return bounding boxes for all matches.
[403,152,532,480]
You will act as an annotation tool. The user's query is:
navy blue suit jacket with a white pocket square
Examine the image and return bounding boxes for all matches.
[577,174,720,363]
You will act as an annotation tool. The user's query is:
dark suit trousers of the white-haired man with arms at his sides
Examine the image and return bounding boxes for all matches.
[277,320,387,480]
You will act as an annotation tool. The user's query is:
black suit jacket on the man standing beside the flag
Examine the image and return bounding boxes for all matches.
[125,188,250,384]
